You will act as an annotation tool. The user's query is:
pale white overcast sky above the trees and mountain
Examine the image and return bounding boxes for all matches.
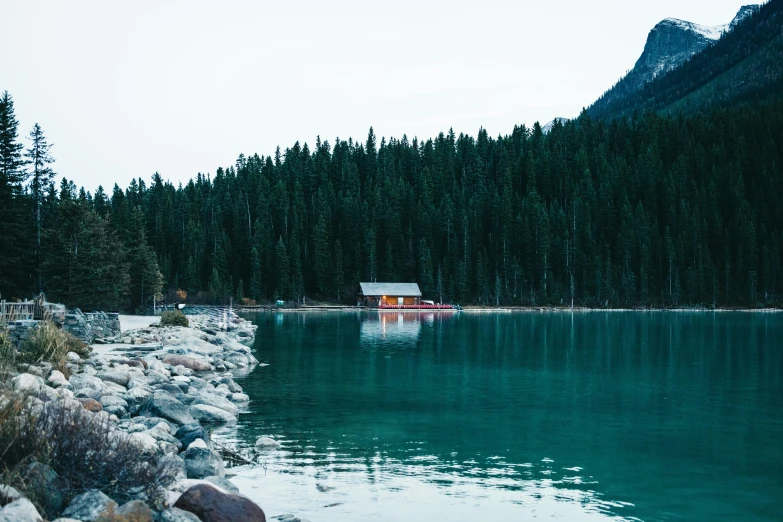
[0,0,747,191]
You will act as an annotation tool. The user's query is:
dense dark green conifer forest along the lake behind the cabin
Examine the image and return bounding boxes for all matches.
[0,89,783,309]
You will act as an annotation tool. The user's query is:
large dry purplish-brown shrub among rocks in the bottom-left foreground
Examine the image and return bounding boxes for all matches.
[0,394,177,519]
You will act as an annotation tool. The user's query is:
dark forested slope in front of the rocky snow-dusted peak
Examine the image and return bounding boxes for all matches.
[587,0,783,119]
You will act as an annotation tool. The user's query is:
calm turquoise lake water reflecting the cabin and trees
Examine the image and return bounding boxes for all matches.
[230,312,783,522]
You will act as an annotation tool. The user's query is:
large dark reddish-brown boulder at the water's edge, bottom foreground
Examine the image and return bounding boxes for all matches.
[174,484,266,522]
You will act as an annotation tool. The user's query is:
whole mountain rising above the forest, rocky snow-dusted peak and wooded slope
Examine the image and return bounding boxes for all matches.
[587,0,782,118]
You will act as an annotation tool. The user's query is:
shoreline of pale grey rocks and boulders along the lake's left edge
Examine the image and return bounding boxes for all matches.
[0,314,270,522]
